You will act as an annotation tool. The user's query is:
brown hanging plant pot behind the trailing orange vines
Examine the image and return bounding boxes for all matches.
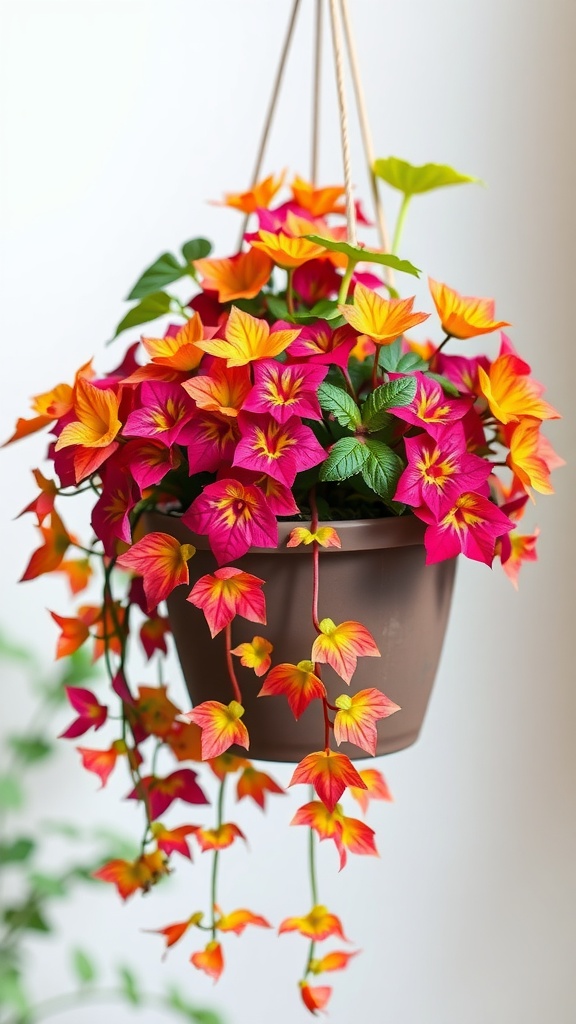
[146,513,456,761]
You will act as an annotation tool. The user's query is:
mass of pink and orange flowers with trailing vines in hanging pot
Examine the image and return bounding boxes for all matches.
[6,162,561,1013]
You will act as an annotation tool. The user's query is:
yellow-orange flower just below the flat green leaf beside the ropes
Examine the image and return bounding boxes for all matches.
[338,283,429,345]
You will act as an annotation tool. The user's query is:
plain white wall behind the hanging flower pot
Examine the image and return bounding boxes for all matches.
[0,0,576,1024]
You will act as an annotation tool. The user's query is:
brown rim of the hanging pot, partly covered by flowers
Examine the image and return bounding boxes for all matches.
[143,512,426,557]
